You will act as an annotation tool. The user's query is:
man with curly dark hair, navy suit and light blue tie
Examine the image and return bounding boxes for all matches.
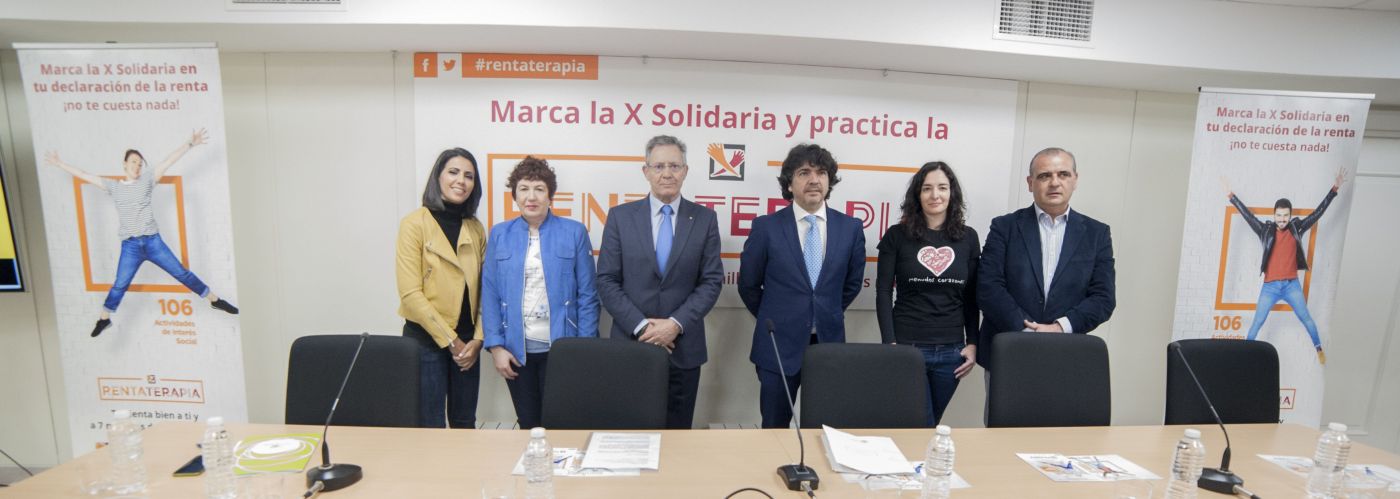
[739,144,865,428]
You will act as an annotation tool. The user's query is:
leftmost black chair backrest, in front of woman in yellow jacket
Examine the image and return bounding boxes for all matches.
[286,335,419,428]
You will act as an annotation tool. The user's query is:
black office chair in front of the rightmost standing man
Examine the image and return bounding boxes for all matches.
[987,332,1113,428]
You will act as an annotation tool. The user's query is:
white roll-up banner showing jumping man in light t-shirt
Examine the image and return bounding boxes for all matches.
[15,43,248,454]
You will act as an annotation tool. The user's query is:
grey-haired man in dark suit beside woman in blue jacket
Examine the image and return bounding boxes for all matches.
[596,135,724,429]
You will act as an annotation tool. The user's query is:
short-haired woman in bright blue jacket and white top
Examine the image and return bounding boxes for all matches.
[482,157,598,428]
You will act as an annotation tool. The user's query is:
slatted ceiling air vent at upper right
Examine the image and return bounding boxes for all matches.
[993,0,1093,46]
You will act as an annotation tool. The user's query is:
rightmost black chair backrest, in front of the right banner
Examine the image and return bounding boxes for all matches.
[1165,339,1278,425]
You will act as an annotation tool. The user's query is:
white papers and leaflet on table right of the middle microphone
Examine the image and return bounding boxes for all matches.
[822,425,972,491]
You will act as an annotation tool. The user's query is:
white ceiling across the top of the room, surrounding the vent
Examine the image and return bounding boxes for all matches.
[0,0,1400,105]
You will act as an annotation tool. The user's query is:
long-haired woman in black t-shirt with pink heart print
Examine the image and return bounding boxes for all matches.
[875,161,981,426]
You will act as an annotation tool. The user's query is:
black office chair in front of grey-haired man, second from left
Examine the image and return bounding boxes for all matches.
[540,338,671,430]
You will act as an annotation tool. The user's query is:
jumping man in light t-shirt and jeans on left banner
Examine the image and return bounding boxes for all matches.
[43,129,238,338]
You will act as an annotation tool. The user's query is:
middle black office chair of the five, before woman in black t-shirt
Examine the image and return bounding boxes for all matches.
[799,343,928,428]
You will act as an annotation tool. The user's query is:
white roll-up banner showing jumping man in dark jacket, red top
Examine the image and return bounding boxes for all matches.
[1172,88,1372,426]
